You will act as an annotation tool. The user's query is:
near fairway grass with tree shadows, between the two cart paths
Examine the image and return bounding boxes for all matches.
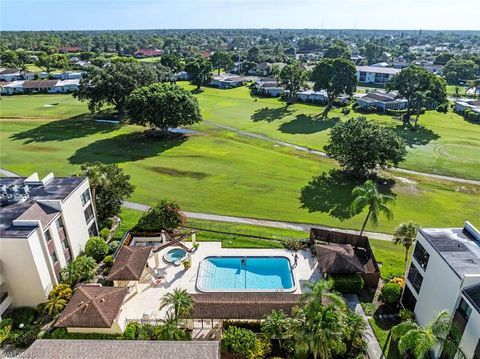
[0,97,480,232]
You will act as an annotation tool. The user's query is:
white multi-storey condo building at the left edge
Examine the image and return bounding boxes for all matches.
[0,173,98,317]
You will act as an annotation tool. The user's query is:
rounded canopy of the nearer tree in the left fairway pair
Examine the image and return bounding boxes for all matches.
[126,83,202,134]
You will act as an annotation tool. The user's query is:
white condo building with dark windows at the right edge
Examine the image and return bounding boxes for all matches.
[402,221,480,359]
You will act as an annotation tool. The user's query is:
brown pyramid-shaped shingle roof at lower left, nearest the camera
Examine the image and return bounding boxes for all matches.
[55,285,128,328]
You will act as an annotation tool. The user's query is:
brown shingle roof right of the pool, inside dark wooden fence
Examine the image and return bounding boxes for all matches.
[315,243,374,274]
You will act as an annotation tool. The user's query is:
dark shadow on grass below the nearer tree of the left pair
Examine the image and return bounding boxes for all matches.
[68,132,188,164]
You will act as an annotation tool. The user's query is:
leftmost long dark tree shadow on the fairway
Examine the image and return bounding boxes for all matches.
[10,114,120,143]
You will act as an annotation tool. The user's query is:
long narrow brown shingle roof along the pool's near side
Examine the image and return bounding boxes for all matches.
[192,293,300,319]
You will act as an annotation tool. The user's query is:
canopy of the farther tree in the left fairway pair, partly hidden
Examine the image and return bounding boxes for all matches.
[74,62,172,115]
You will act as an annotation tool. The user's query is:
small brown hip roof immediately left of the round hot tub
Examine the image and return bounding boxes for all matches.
[108,246,152,280]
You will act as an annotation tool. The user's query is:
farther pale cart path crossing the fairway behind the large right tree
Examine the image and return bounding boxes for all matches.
[203,121,480,186]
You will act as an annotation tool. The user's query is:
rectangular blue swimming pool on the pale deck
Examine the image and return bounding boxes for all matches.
[197,256,296,292]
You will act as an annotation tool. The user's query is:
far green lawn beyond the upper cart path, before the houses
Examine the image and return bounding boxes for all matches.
[181,82,480,179]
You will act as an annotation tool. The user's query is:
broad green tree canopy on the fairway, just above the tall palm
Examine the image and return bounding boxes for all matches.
[325,117,407,177]
